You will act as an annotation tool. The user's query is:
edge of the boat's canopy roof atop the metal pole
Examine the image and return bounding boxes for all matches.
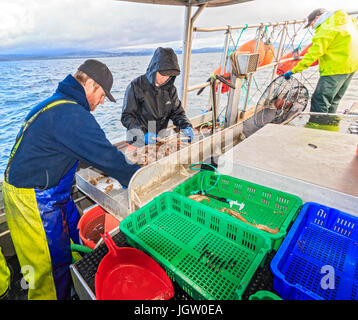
[119,0,252,7]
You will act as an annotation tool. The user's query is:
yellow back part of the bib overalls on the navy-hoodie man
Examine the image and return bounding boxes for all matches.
[3,180,56,300]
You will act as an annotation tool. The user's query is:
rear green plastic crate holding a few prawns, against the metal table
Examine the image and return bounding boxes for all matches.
[173,171,302,250]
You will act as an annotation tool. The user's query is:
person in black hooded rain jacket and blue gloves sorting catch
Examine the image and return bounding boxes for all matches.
[121,47,194,145]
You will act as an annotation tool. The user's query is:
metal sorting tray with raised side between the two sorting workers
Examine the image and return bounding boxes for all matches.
[76,123,243,220]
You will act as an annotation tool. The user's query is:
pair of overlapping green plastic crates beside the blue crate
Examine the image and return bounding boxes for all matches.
[120,171,302,300]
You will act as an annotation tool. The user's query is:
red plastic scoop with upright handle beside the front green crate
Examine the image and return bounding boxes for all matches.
[95,233,174,300]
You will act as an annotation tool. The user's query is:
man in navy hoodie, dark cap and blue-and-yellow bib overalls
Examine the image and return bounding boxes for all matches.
[3,59,140,299]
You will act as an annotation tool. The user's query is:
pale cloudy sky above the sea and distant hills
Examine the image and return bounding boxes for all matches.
[0,0,358,54]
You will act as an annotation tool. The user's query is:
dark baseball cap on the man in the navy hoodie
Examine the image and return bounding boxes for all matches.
[78,59,116,102]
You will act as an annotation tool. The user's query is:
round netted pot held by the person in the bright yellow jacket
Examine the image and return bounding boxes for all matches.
[254,76,308,127]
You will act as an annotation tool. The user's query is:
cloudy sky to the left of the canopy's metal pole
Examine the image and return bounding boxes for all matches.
[0,0,184,52]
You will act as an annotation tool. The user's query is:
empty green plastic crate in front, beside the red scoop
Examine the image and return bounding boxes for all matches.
[120,192,271,300]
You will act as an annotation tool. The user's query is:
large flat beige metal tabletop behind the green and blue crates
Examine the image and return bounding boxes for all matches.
[218,124,358,216]
